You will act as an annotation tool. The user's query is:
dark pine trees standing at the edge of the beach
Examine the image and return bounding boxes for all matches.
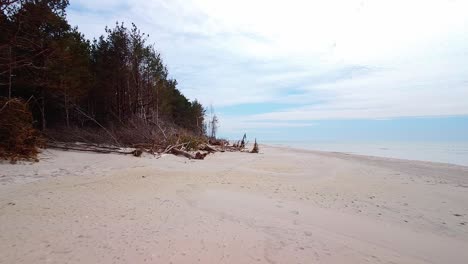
[0,0,206,139]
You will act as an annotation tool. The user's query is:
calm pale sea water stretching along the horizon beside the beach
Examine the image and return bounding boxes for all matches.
[264,141,468,166]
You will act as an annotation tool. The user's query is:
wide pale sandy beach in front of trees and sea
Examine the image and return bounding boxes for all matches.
[0,146,468,264]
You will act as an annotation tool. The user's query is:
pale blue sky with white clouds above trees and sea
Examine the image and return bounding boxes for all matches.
[68,0,468,141]
